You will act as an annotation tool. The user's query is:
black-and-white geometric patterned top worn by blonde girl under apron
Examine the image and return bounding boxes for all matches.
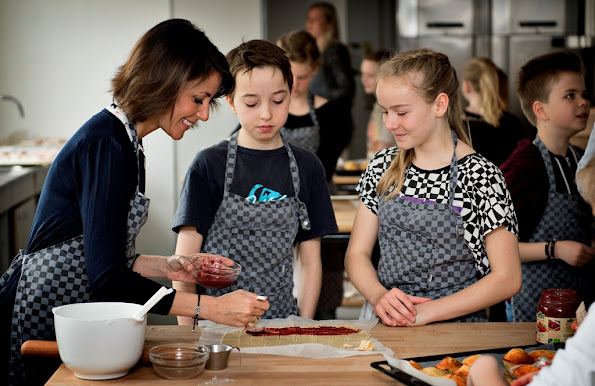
[356,147,518,275]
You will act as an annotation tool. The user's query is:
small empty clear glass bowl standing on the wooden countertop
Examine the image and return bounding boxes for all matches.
[149,343,210,379]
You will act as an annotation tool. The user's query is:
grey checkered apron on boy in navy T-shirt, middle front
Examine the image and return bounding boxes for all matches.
[203,133,310,318]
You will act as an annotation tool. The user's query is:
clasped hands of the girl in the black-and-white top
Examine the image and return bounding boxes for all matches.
[374,288,432,327]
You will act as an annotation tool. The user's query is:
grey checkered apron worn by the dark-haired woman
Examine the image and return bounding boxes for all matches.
[0,105,149,384]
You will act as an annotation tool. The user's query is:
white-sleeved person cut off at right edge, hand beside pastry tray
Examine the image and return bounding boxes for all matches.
[467,158,595,386]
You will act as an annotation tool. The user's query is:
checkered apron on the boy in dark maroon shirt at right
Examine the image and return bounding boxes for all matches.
[510,137,595,322]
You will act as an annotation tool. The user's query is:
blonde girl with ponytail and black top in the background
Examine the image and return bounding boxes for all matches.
[461,58,523,166]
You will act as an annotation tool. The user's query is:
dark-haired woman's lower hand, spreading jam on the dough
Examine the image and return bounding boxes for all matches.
[205,290,271,327]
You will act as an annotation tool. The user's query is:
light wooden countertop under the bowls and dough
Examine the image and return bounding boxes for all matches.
[47,322,536,386]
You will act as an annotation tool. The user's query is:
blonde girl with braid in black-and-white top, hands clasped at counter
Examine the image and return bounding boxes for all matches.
[345,49,521,326]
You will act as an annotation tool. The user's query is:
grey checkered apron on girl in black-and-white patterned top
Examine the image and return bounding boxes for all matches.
[360,132,488,322]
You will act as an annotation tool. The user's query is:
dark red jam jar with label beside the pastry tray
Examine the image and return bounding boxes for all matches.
[537,288,580,343]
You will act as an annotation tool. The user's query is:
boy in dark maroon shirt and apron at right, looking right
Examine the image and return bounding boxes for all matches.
[501,51,595,321]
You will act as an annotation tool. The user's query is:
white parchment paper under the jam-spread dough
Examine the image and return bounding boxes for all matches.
[199,315,394,359]
